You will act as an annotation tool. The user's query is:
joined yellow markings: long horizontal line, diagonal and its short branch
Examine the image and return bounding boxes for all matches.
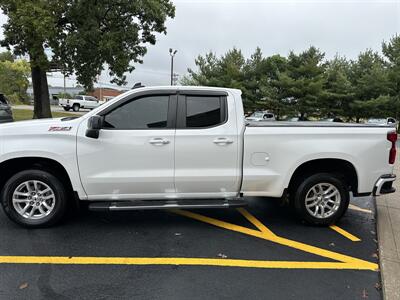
[0,209,378,270]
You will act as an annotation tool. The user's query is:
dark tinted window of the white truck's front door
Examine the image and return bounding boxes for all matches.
[104,96,169,129]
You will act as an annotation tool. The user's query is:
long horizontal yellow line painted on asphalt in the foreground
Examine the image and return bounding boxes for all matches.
[0,256,373,270]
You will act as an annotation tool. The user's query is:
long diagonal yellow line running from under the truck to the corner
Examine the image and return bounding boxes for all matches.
[171,209,378,270]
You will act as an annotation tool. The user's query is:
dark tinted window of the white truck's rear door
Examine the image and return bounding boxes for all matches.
[186,96,226,128]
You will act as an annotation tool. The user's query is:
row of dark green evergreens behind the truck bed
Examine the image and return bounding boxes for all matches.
[181,35,400,122]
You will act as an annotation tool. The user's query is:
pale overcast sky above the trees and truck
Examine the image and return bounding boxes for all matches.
[0,0,400,87]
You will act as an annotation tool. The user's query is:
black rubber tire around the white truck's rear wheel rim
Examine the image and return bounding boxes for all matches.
[292,173,350,225]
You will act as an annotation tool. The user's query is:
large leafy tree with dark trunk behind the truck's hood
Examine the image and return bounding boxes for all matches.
[0,0,175,118]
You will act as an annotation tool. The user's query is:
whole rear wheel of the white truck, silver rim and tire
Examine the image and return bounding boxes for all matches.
[292,173,350,225]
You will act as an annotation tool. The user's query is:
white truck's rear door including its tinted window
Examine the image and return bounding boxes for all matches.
[175,91,239,198]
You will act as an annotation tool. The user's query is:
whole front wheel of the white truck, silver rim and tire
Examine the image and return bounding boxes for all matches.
[1,170,67,228]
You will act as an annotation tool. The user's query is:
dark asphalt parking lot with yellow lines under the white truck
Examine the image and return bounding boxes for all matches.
[0,198,381,299]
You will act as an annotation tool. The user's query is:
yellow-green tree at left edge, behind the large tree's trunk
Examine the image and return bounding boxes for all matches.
[0,51,30,103]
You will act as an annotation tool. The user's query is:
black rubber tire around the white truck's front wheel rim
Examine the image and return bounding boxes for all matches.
[1,170,67,228]
